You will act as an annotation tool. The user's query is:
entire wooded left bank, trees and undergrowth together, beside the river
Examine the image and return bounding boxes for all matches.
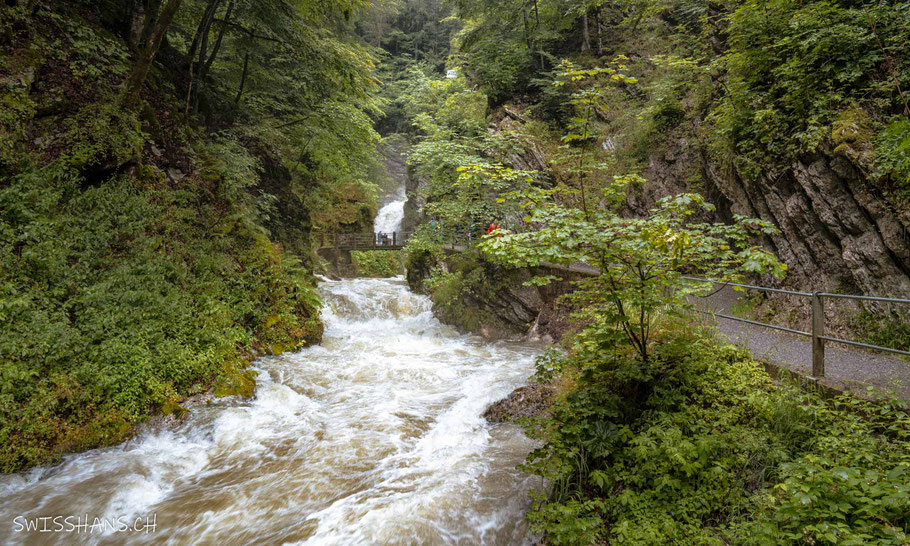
[0,0,379,471]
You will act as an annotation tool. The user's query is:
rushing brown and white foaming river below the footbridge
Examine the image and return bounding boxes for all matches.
[0,279,537,545]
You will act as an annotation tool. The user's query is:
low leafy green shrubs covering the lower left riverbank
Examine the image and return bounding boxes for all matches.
[0,163,321,472]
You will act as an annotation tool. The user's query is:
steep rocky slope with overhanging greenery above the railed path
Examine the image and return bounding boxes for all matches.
[604,2,910,302]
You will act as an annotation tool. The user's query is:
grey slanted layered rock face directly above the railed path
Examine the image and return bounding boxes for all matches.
[707,154,910,296]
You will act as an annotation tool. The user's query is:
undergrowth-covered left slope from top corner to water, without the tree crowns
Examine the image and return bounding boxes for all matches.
[0,3,322,472]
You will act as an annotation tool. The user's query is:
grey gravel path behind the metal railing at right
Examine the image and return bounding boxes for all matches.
[696,287,910,400]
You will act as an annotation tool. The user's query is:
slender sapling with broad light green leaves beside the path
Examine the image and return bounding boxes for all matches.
[479,175,786,361]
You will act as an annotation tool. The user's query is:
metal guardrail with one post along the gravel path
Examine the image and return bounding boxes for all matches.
[683,276,910,378]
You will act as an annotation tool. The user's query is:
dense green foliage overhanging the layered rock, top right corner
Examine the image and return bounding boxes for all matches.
[716,1,910,183]
